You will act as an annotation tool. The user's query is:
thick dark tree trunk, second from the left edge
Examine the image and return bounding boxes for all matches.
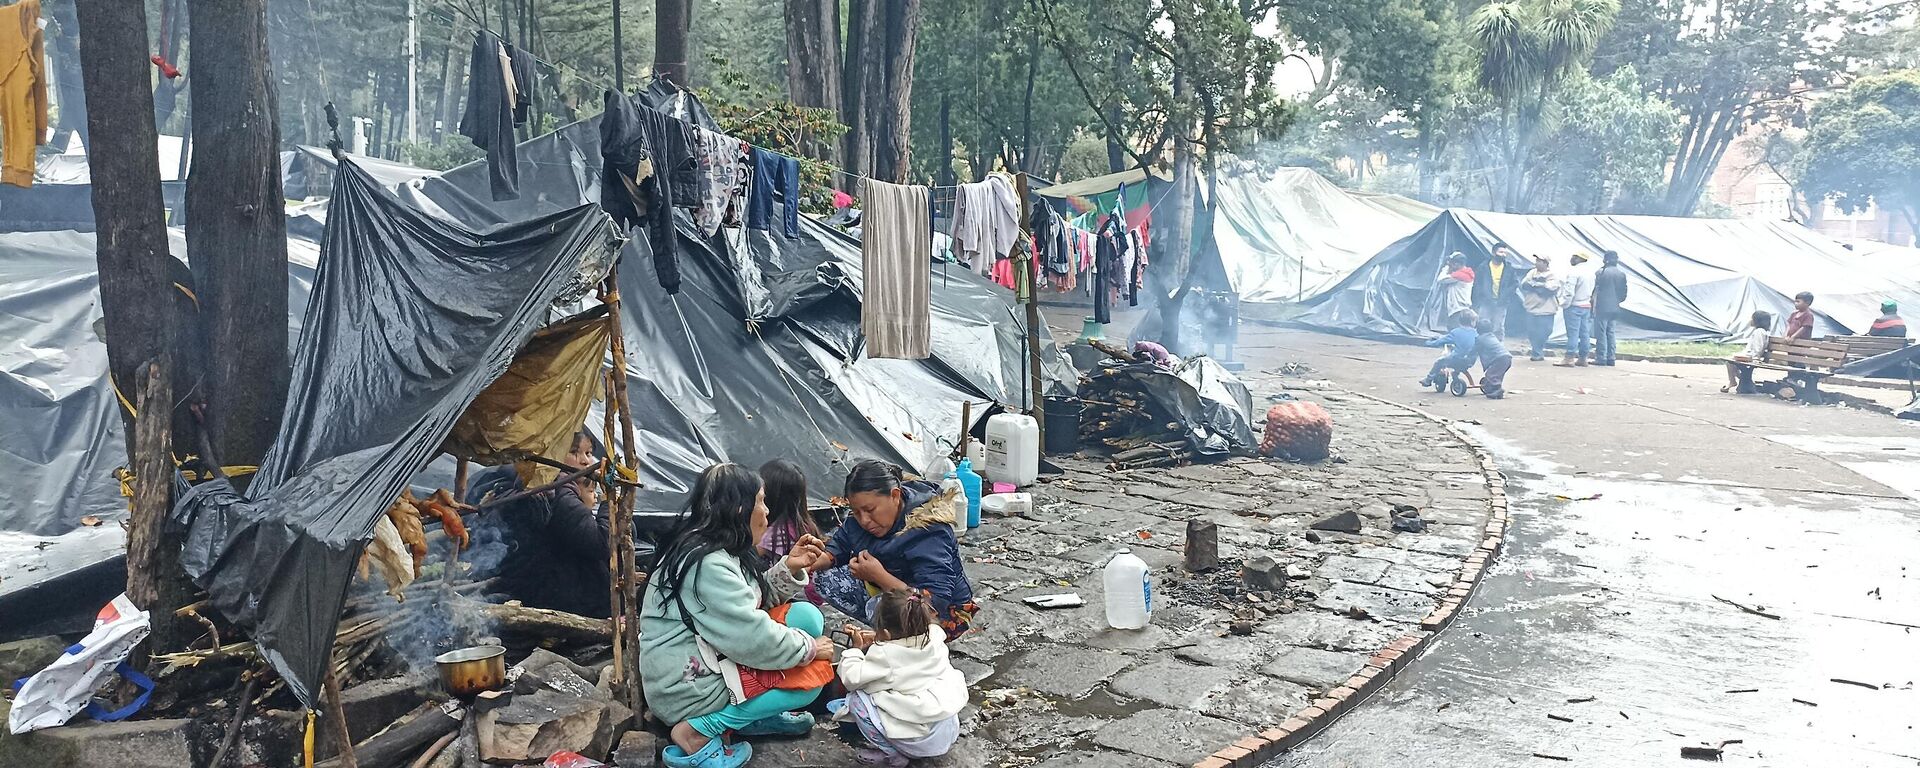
[186,0,288,488]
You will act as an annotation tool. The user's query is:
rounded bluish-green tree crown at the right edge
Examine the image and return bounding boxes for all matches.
[1801,69,1920,225]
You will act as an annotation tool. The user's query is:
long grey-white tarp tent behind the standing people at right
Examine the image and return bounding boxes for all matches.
[1300,209,1920,338]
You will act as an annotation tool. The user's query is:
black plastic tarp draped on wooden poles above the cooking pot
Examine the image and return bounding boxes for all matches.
[175,163,614,705]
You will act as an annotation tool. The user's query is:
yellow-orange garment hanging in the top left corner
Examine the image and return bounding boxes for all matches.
[0,0,43,186]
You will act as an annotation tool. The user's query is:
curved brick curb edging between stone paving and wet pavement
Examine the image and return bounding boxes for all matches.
[1192,390,1509,768]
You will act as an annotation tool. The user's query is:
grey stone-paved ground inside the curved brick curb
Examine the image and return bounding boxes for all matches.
[755,371,1490,768]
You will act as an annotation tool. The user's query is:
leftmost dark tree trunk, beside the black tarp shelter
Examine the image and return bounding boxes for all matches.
[75,0,197,651]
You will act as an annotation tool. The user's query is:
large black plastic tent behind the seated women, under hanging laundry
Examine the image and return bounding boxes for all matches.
[399,100,1077,516]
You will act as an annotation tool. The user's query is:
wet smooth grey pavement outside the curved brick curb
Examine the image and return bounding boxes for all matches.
[1213,328,1920,768]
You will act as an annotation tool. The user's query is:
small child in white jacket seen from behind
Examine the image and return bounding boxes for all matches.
[828,589,968,768]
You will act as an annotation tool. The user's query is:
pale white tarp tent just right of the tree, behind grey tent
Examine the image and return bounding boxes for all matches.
[1213,167,1440,301]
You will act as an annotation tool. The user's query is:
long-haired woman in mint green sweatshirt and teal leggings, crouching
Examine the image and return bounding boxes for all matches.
[639,465,833,768]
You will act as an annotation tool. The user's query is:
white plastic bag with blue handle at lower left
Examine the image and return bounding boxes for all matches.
[6,593,152,733]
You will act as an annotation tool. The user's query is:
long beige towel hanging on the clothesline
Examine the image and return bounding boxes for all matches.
[867,179,933,359]
